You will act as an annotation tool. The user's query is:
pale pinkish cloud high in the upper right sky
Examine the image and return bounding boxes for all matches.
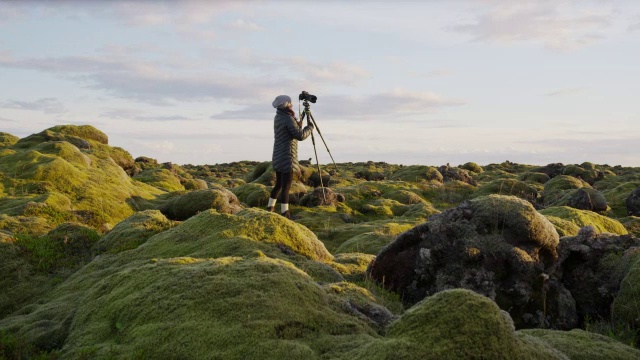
[450,1,613,50]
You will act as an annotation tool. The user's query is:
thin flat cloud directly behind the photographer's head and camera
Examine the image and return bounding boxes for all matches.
[211,89,464,120]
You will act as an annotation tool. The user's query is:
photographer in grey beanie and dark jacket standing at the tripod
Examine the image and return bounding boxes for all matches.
[267,95,313,219]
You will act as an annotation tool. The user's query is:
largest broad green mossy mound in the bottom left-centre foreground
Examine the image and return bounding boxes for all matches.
[28,257,375,359]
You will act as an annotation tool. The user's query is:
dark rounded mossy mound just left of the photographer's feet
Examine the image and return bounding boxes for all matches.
[158,187,242,221]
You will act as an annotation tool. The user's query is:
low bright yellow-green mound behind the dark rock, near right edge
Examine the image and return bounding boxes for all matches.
[540,206,629,235]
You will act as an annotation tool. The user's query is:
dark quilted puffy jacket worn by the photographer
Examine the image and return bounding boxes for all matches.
[271,109,313,172]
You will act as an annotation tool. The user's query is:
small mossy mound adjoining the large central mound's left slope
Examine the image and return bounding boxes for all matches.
[96,210,174,254]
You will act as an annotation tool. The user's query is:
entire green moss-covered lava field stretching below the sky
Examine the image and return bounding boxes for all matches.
[0,125,640,359]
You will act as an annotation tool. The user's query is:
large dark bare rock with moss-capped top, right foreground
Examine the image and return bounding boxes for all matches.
[368,195,564,327]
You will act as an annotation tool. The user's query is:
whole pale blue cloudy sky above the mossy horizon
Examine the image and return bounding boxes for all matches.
[0,0,640,166]
